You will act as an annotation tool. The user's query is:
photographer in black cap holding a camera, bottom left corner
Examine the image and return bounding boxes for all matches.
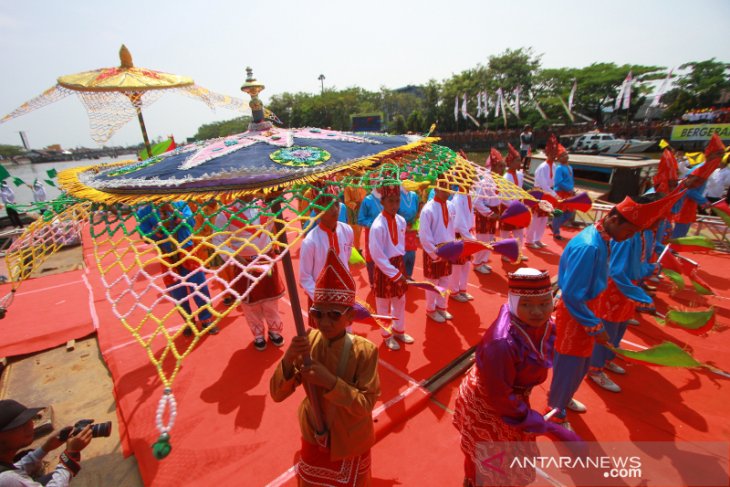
[0,399,98,487]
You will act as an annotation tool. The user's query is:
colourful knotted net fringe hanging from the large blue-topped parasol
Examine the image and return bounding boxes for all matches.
[5,143,532,455]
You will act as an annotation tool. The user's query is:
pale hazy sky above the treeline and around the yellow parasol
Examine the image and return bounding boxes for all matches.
[0,0,730,148]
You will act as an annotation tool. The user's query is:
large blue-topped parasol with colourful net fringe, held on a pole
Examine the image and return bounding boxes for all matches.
[0,68,531,458]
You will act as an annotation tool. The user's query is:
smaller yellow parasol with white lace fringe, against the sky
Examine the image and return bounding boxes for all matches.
[0,45,247,154]
